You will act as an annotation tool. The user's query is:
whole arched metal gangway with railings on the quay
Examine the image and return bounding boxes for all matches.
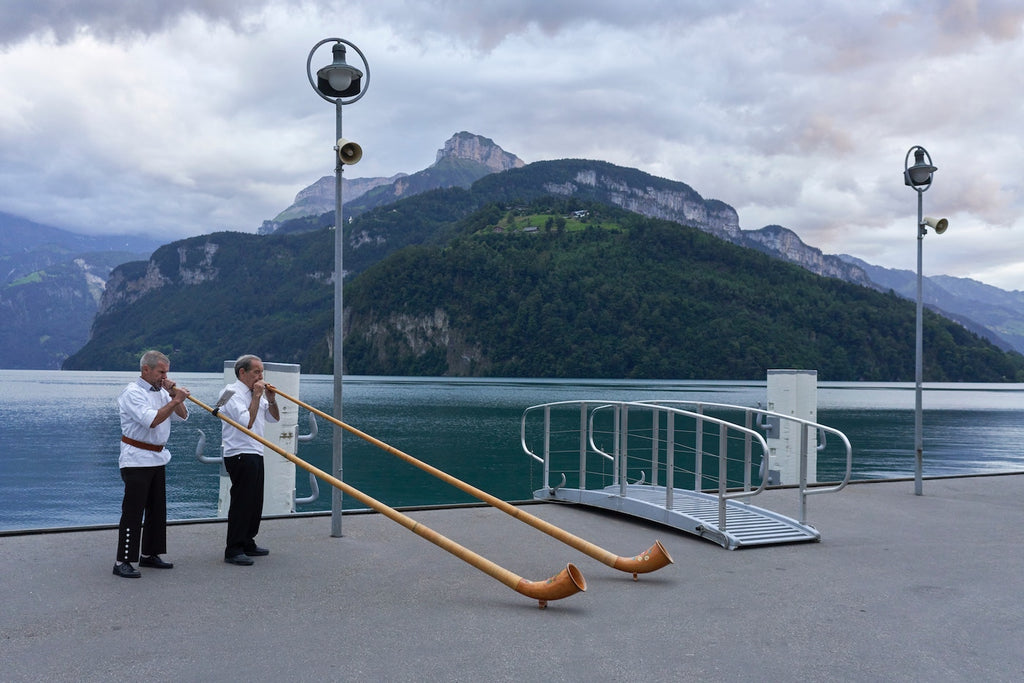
[520,400,852,550]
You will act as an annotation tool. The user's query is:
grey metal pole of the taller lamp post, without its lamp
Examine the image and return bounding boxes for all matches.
[331,97,345,538]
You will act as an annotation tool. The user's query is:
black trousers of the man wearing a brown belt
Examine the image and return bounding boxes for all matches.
[118,465,167,562]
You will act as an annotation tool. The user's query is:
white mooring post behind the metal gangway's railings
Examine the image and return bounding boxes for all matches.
[766,370,818,484]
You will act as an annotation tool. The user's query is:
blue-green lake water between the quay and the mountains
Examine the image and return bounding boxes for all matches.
[0,368,1024,530]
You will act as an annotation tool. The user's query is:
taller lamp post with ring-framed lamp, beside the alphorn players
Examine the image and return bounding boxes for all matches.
[306,38,370,538]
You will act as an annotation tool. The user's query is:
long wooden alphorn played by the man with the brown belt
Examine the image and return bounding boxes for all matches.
[188,390,587,609]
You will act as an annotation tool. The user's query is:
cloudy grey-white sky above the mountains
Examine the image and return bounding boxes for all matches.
[6,0,1024,290]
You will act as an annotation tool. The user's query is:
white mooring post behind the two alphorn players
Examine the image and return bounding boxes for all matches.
[217,360,300,517]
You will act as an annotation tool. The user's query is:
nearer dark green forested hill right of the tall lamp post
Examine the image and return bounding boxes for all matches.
[345,198,1024,382]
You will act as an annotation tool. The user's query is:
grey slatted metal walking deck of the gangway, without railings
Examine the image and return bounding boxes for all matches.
[534,484,821,550]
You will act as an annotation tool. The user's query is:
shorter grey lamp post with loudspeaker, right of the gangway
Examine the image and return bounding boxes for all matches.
[903,145,949,496]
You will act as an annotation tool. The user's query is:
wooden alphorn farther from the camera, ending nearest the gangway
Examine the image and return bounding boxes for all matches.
[271,387,672,581]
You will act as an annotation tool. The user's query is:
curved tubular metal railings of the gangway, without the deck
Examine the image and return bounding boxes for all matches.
[520,400,853,530]
